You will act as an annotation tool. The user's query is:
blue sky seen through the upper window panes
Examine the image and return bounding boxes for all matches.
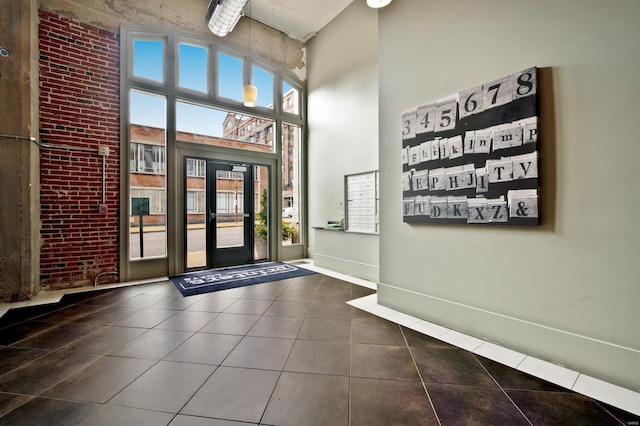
[130,40,291,136]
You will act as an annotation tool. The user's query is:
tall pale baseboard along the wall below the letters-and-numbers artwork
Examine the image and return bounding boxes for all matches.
[378,283,640,392]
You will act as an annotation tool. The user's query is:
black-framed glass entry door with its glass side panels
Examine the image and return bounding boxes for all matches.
[186,159,269,270]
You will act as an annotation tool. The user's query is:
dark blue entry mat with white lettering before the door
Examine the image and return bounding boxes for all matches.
[169,262,315,296]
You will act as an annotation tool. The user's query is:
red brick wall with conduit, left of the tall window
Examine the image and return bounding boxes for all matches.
[39,11,120,289]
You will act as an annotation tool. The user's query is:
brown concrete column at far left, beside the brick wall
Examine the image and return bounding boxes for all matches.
[0,0,40,302]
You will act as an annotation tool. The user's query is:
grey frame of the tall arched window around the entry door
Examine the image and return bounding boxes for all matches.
[120,25,306,279]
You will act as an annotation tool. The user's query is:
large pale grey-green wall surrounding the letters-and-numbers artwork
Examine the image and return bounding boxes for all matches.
[378,0,640,390]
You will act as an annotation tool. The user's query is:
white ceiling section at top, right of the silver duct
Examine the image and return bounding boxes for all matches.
[245,0,356,42]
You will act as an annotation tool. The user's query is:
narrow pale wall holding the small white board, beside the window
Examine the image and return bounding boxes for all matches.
[307,1,379,281]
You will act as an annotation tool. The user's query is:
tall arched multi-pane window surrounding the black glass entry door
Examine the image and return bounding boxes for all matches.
[126,27,304,260]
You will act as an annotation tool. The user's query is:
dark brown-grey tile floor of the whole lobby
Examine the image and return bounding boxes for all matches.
[0,274,638,426]
